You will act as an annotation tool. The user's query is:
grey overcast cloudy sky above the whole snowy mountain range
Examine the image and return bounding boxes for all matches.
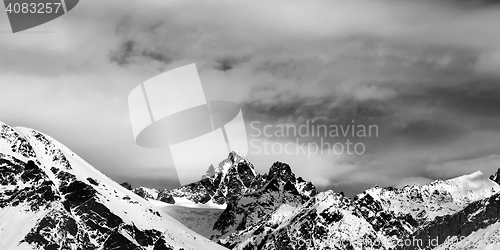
[0,0,500,195]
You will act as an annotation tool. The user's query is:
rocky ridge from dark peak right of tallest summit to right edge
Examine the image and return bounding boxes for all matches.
[212,166,500,250]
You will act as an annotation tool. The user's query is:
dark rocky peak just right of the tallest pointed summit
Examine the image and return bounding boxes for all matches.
[212,162,316,248]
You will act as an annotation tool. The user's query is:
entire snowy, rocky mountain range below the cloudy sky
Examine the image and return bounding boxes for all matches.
[0,121,500,250]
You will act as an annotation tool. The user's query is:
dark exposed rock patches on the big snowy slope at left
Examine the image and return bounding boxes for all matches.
[0,145,168,249]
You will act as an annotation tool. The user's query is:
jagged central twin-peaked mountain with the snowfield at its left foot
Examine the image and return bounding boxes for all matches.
[129,151,316,247]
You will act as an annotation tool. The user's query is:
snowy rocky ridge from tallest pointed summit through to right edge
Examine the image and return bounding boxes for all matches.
[123,148,500,250]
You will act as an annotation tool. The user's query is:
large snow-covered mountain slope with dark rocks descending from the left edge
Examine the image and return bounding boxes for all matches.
[0,123,224,250]
